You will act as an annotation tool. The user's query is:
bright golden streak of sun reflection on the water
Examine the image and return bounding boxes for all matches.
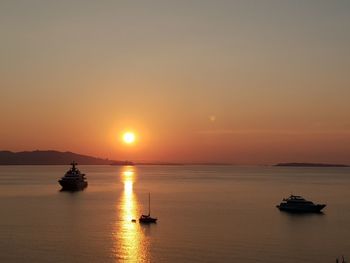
[114,166,150,262]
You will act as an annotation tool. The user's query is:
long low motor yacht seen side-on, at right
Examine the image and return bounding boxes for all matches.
[277,195,326,212]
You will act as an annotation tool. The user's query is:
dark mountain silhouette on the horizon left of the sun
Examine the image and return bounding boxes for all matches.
[0,151,130,165]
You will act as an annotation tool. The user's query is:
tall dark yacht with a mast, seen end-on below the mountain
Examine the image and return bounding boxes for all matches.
[58,162,88,191]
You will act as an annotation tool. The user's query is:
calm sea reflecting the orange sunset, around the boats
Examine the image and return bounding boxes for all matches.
[0,165,350,263]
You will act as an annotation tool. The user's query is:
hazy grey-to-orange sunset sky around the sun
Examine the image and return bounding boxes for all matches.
[0,0,350,164]
